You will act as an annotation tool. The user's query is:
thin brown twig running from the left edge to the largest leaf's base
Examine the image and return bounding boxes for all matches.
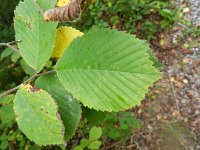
[0,70,55,99]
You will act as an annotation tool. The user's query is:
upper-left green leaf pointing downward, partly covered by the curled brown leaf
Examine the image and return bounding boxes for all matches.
[14,0,57,72]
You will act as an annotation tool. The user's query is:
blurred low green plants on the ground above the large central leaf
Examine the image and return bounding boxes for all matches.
[70,0,178,40]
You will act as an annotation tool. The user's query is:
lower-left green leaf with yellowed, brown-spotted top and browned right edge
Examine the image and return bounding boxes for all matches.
[14,85,64,145]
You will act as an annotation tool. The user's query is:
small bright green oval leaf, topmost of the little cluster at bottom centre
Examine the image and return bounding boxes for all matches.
[89,126,102,141]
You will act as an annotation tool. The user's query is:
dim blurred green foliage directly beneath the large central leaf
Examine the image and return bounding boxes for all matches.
[83,108,142,143]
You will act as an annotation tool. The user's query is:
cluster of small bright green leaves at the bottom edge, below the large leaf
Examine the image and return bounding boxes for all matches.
[74,126,102,150]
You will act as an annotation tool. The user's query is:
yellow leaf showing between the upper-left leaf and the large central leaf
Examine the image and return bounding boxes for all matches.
[51,27,83,58]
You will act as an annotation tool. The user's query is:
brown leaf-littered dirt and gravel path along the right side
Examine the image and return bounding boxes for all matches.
[130,0,200,150]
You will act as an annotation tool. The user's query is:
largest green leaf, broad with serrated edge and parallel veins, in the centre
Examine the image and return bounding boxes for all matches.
[56,28,162,111]
